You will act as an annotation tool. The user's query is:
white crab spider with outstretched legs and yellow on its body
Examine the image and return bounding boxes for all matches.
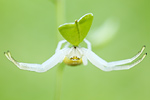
[5,39,147,72]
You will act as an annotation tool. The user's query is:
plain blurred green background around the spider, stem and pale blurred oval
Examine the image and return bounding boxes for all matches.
[0,0,150,100]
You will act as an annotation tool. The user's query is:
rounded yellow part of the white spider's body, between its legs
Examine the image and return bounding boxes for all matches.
[63,56,82,66]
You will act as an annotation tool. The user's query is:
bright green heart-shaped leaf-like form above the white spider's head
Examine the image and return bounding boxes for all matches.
[58,13,93,46]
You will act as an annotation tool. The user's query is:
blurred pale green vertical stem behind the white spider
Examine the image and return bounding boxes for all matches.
[54,0,65,100]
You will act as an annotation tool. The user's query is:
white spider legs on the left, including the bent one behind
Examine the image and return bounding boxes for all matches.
[4,41,68,72]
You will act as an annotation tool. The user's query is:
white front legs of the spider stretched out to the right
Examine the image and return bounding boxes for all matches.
[83,46,147,71]
